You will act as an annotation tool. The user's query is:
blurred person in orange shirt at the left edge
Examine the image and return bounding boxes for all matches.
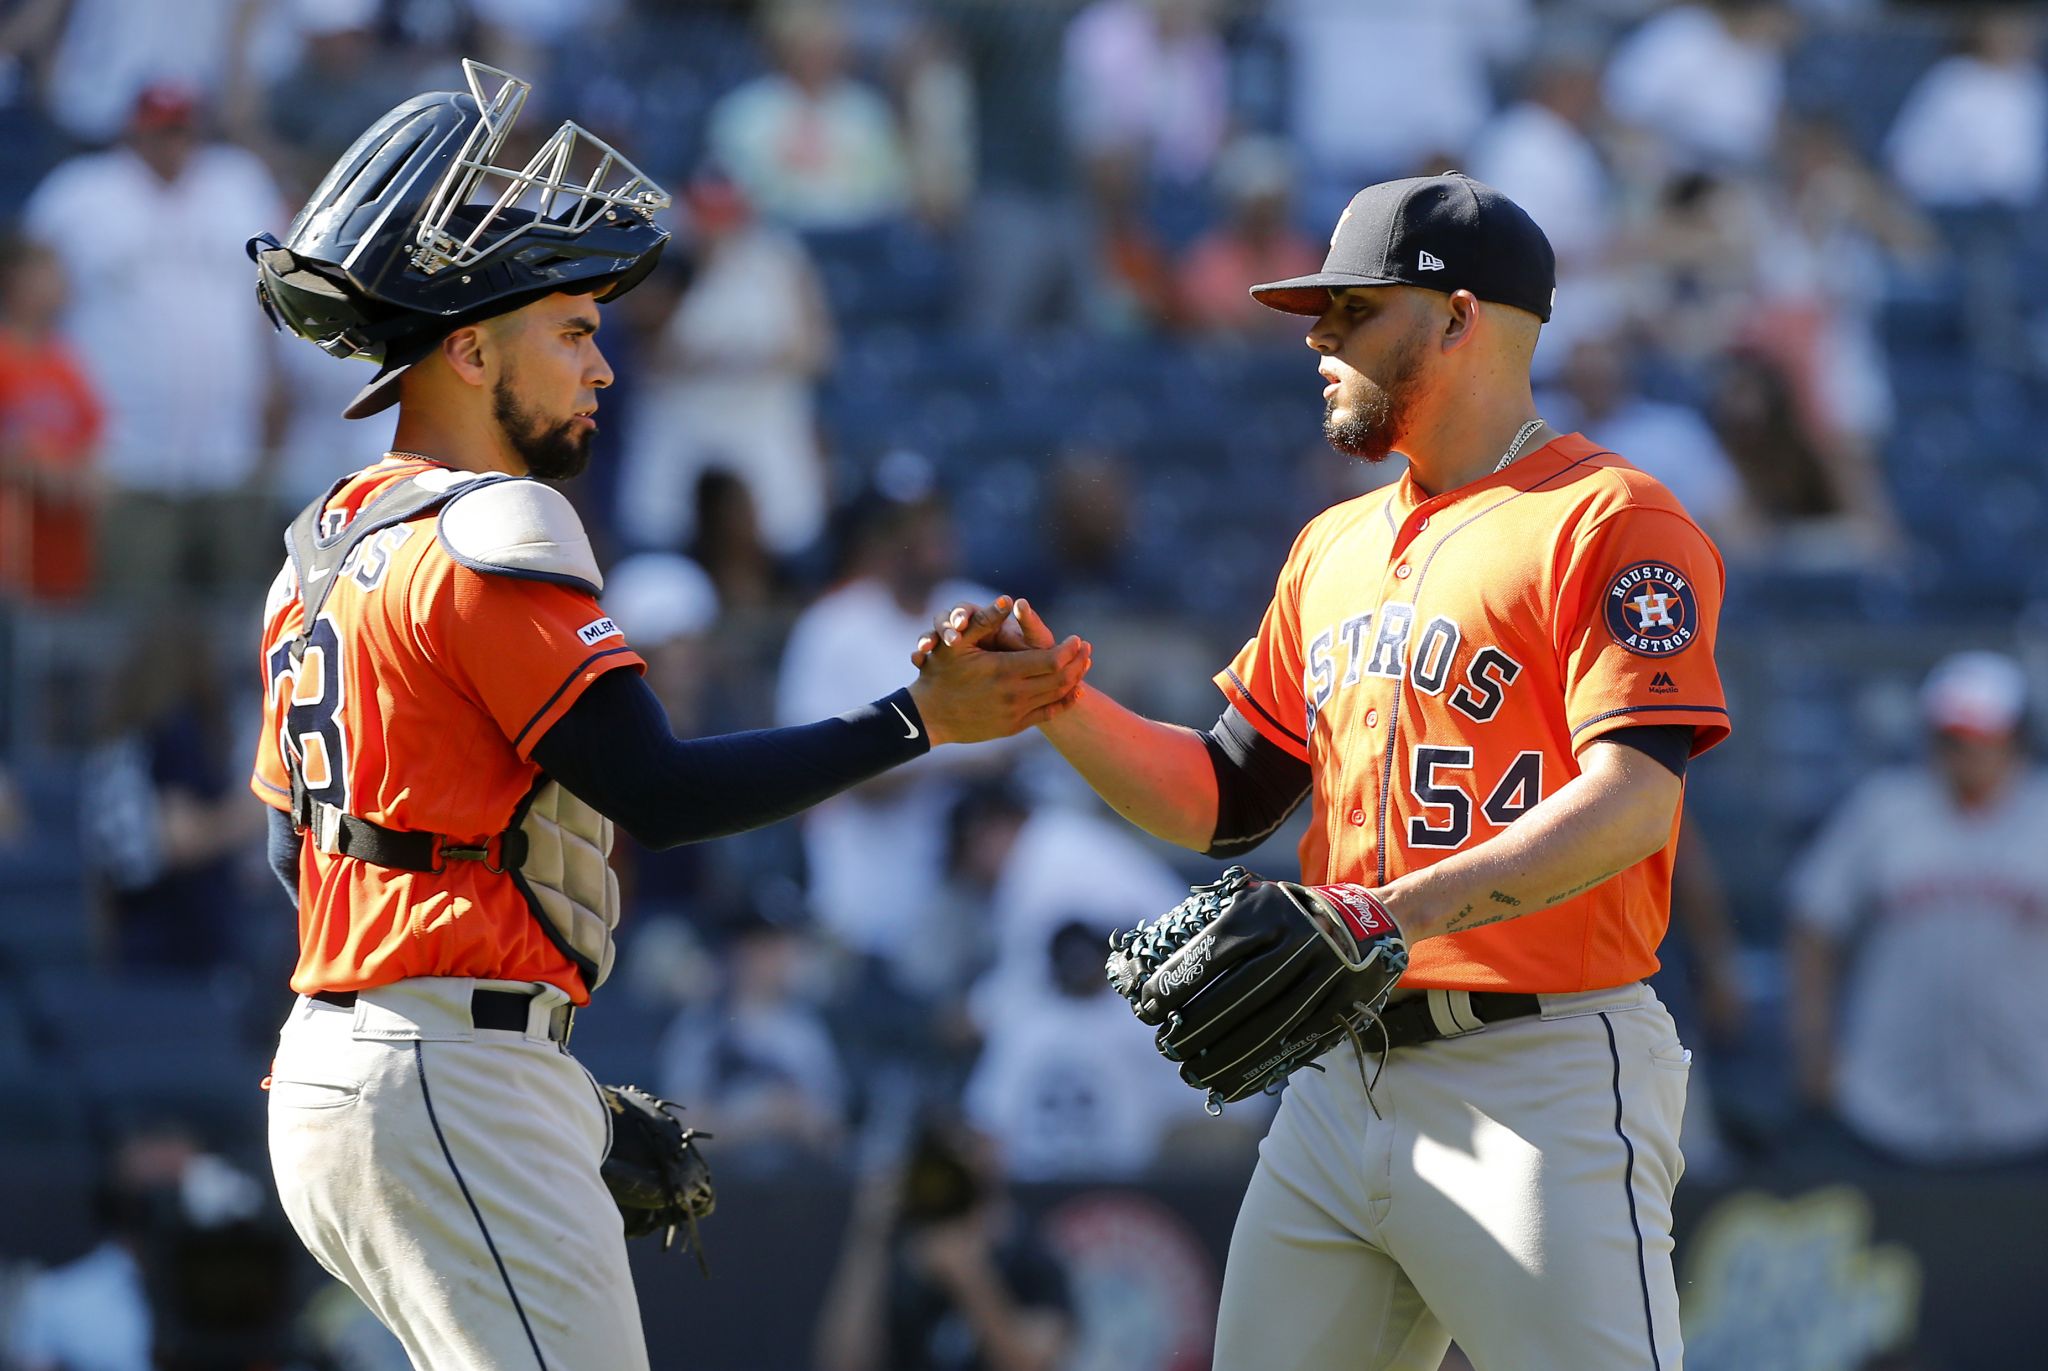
[0,238,100,605]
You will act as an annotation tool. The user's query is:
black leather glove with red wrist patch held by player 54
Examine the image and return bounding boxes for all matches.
[1108,867,1407,1113]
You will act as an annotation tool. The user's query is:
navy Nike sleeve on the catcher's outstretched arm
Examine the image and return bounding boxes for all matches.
[532,670,932,848]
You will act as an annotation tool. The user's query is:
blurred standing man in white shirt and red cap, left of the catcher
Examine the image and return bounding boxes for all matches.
[25,86,281,603]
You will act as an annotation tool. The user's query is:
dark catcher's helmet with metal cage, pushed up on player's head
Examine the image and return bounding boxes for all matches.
[248,61,670,418]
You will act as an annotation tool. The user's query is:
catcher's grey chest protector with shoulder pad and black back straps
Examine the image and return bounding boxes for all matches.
[285,471,618,990]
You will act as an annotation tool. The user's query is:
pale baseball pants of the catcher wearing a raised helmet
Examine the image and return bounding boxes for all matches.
[270,978,647,1371]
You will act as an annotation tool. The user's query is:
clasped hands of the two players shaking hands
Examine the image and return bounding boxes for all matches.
[909,594,1094,748]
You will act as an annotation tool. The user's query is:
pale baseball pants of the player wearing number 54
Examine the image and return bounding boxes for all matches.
[1214,984,1690,1371]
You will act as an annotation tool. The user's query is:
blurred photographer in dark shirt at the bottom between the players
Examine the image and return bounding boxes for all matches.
[813,1125,1073,1371]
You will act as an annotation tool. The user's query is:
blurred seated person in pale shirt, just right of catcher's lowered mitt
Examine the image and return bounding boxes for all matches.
[659,887,850,1172]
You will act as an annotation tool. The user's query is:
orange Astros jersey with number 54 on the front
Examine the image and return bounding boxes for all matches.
[1217,434,1729,992]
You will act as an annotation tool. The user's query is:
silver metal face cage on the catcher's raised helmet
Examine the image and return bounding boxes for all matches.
[412,57,670,275]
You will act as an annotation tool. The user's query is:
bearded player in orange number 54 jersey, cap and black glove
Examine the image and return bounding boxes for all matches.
[920,174,1729,1371]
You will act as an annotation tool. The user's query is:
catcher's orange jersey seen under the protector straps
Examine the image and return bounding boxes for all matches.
[250,459,645,1004]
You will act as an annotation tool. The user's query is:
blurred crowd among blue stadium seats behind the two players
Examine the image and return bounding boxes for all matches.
[0,0,2048,1369]
